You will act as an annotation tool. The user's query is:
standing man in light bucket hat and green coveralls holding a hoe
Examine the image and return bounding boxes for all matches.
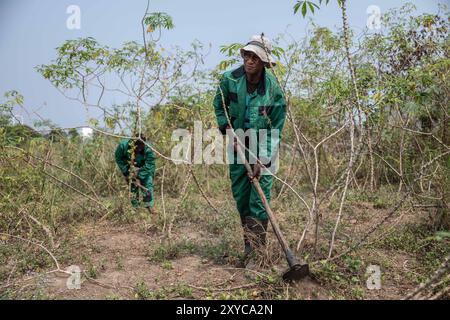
[213,35,286,263]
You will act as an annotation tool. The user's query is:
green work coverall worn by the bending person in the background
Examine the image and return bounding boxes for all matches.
[115,140,155,208]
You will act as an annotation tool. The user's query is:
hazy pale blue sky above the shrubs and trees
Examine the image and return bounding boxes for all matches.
[0,0,449,127]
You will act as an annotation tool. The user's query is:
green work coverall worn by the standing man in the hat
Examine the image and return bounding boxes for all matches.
[213,66,286,221]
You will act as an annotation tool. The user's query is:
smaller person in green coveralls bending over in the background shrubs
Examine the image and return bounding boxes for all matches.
[115,135,155,213]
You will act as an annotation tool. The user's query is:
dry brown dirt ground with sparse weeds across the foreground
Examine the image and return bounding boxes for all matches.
[1,192,448,300]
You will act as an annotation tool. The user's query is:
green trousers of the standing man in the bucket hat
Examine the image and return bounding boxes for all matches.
[229,164,273,220]
